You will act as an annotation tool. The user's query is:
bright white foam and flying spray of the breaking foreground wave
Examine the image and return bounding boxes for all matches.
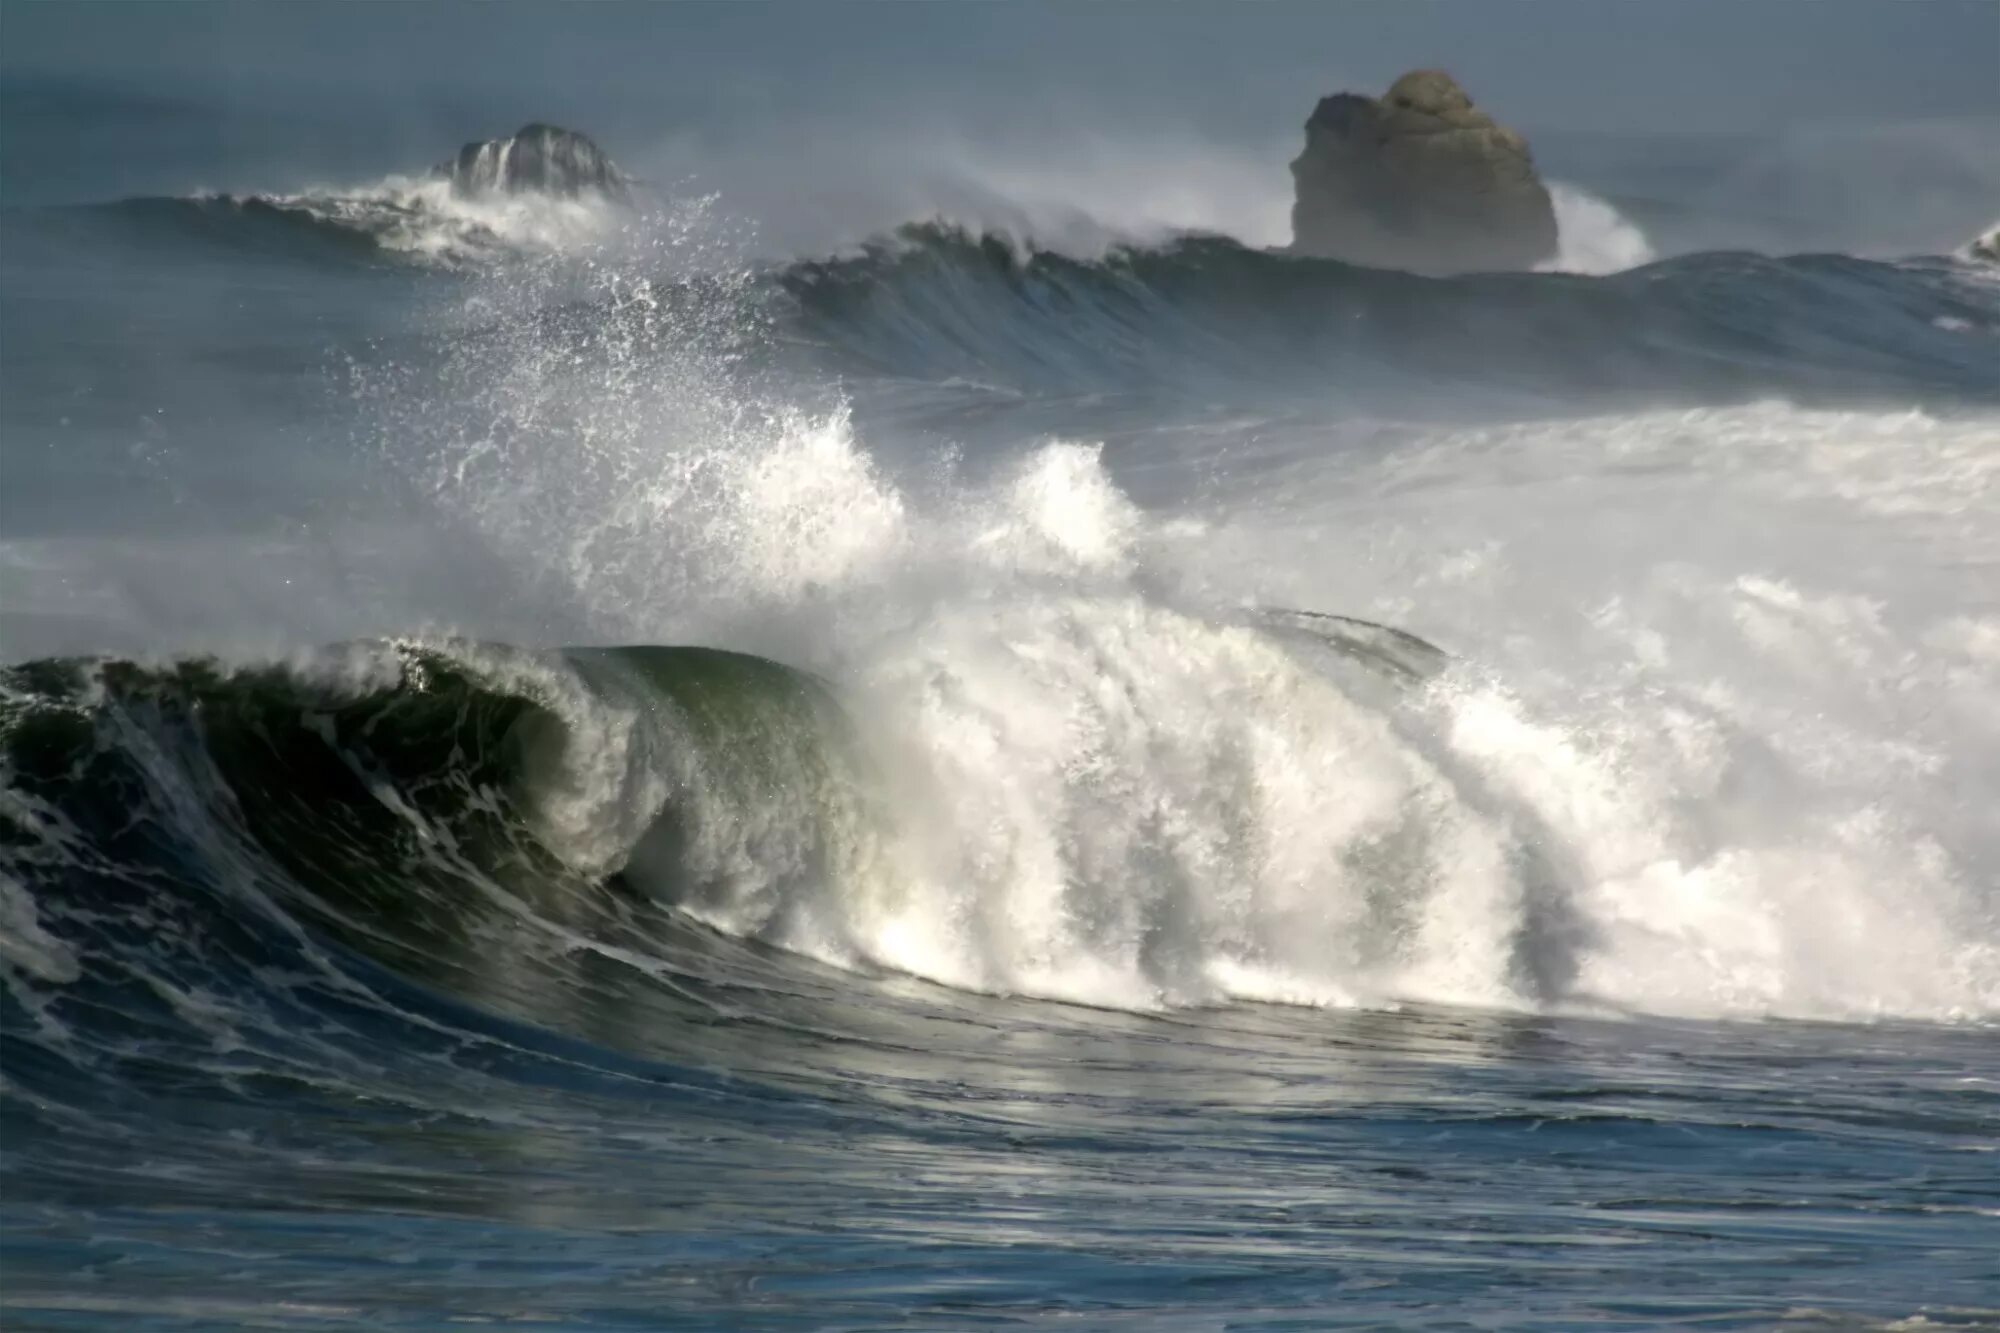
[378,252,2000,1019]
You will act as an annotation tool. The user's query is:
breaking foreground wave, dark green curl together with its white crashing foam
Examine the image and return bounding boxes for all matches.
[15,400,2000,1029]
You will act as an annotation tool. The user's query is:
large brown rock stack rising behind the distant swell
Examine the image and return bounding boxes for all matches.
[1292,70,1556,274]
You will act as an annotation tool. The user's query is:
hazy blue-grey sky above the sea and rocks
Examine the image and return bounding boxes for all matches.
[0,0,2000,138]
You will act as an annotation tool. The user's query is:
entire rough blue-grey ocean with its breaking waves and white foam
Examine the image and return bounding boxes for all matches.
[0,70,2000,1333]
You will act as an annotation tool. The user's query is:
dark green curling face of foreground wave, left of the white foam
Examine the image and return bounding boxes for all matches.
[0,644,862,1009]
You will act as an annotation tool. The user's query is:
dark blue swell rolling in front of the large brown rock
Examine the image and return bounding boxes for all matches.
[780,224,2000,402]
